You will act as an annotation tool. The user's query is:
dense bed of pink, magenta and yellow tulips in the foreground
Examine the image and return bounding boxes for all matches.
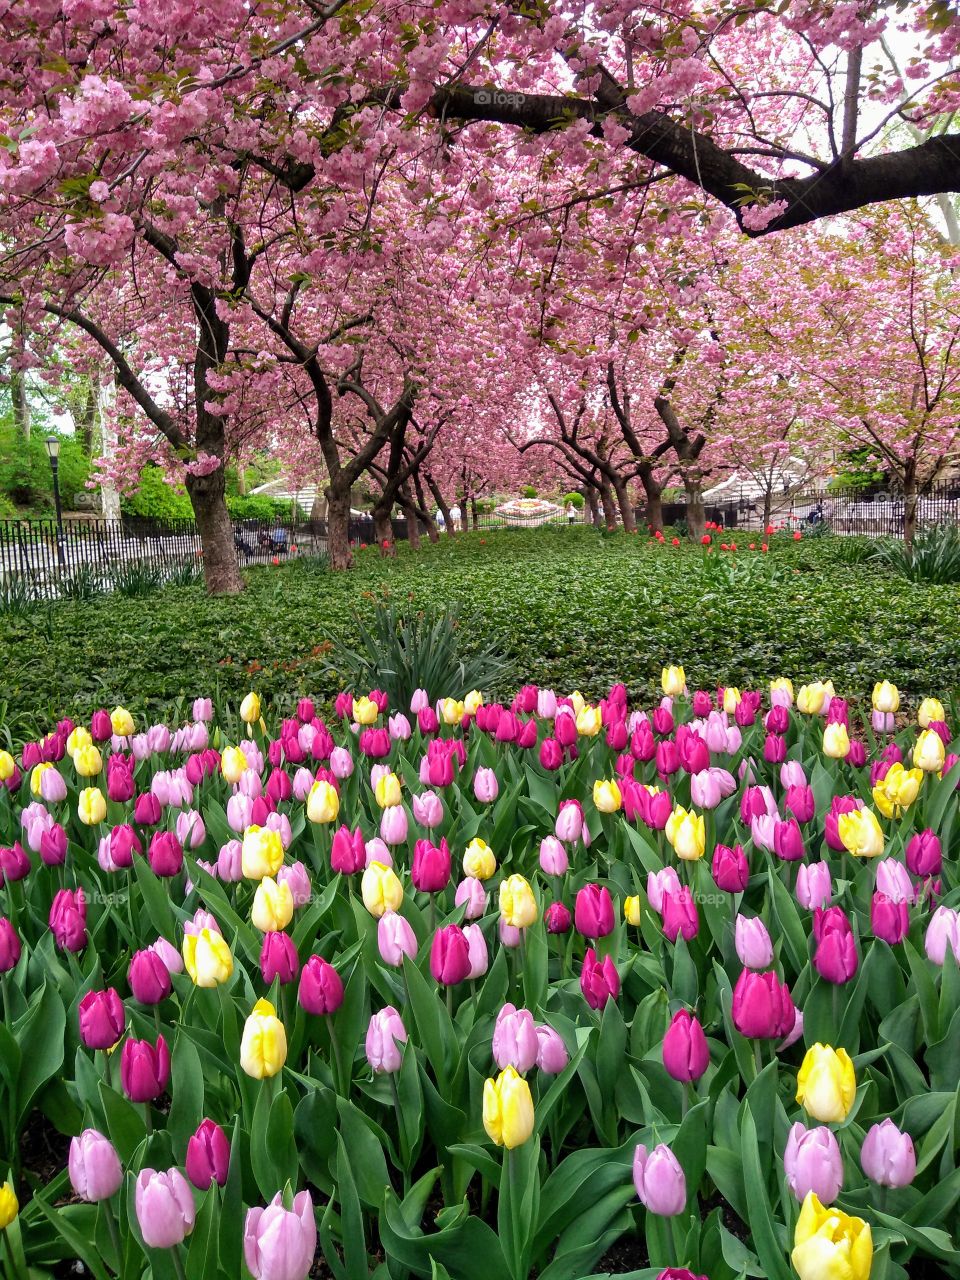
[0,668,960,1280]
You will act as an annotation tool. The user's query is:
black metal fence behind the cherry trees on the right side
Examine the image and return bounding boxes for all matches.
[637,481,960,538]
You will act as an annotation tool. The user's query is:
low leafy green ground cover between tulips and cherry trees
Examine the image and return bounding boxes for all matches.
[0,527,960,737]
